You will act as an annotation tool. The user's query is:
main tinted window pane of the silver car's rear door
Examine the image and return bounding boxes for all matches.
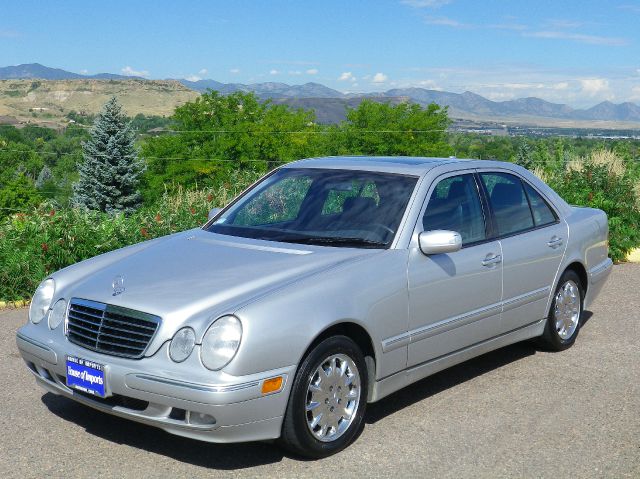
[480,173,534,236]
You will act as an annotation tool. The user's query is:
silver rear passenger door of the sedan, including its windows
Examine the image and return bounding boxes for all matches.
[479,171,568,331]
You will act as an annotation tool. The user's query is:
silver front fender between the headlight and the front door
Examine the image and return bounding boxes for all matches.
[230,250,408,378]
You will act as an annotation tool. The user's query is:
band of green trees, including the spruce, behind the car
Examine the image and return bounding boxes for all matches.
[0,91,640,216]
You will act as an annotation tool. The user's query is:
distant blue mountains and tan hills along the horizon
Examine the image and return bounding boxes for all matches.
[0,63,640,128]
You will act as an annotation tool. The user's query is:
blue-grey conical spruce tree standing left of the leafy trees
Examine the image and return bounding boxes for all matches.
[72,97,145,213]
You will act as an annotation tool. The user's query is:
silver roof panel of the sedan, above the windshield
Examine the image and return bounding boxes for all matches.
[283,156,474,176]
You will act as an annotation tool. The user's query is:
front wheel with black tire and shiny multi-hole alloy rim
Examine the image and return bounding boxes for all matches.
[280,336,368,459]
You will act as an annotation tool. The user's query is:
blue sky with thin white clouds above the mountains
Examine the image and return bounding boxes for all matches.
[0,0,640,106]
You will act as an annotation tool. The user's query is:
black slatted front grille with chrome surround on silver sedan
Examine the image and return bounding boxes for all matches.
[66,298,160,358]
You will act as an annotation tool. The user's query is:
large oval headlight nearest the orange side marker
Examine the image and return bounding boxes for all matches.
[200,316,242,371]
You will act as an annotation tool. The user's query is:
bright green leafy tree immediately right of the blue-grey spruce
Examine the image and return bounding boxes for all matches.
[142,91,319,200]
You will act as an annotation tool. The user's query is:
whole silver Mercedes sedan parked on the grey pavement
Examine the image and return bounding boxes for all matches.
[17,157,612,457]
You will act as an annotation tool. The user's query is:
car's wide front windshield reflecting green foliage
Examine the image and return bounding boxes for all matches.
[207,168,417,248]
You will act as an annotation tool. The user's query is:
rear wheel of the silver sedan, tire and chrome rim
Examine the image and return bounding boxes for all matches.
[538,270,584,351]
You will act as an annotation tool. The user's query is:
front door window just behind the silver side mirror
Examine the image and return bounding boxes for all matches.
[422,175,486,245]
